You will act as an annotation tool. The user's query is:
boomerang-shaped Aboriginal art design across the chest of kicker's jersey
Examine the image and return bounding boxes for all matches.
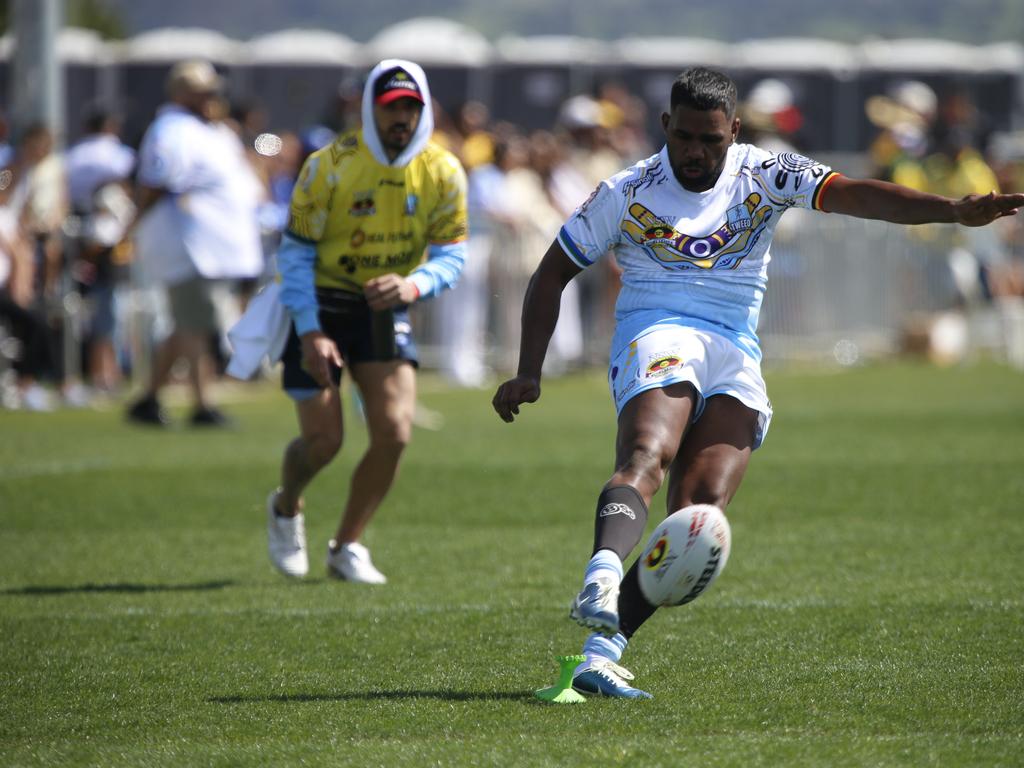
[622,191,775,269]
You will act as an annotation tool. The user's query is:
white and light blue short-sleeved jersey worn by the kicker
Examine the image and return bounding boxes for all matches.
[558,144,836,360]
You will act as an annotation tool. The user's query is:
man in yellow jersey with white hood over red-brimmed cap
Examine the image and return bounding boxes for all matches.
[266,59,467,584]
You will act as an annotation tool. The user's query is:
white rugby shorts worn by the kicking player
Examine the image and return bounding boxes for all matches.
[608,323,772,447]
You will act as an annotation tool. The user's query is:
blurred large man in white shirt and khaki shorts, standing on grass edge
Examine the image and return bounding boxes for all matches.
[127,60,263,426]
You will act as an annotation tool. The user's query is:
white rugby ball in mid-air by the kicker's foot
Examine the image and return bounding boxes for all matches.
[637,504,732,605]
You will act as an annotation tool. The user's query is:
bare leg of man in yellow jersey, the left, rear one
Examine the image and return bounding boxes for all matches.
[276,387,343,517]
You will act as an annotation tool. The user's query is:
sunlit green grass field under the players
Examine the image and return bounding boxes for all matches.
[0,366,1024,768]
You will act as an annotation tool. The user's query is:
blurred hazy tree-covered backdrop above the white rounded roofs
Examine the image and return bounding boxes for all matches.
[0,0,1024,44]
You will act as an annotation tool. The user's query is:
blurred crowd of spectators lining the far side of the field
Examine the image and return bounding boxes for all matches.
[0,59,1024,411]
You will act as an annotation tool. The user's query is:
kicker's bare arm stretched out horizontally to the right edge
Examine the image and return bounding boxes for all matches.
[821,176,1024,226]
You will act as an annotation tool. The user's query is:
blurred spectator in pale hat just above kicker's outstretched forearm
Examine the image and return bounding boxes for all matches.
[864,80,938,186]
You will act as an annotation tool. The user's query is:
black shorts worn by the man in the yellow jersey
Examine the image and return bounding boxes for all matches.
[281,290,420,399]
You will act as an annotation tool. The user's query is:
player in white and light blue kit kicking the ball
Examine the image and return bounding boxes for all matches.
[494,68,1024,698]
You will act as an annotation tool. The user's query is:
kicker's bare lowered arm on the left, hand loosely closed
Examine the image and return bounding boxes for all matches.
[492,241,581,422]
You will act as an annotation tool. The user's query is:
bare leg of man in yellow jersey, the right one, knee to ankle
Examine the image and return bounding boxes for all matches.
[335,360,416,546]
